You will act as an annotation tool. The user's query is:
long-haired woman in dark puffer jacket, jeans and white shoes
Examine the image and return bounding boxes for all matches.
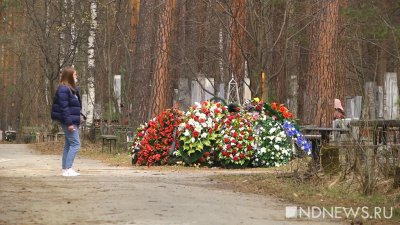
[51,67,81,177]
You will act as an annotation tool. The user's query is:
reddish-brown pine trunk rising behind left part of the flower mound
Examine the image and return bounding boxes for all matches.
[151,0,175,118]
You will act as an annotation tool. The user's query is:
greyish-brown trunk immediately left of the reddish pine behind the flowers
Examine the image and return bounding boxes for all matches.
[128,0,158,127]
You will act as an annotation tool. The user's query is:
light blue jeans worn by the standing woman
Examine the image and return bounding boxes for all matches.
[61,124,81,169]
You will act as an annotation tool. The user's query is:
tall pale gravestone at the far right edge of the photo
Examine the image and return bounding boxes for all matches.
[383,73,399,119]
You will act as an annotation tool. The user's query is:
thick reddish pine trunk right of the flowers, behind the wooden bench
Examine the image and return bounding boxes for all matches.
[305,0,339,127]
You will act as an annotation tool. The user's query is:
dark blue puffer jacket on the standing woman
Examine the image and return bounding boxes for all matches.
[51,84,81,126]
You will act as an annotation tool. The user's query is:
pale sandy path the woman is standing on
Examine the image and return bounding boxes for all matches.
[0,145,340,225]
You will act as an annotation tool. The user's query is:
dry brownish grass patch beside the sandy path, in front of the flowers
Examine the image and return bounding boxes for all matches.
[212,170,400,225]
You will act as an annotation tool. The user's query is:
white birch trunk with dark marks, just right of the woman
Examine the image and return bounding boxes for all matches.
[86,0,97,126]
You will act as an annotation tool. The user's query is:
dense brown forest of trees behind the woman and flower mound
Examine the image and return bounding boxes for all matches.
[0,0,400,130]
